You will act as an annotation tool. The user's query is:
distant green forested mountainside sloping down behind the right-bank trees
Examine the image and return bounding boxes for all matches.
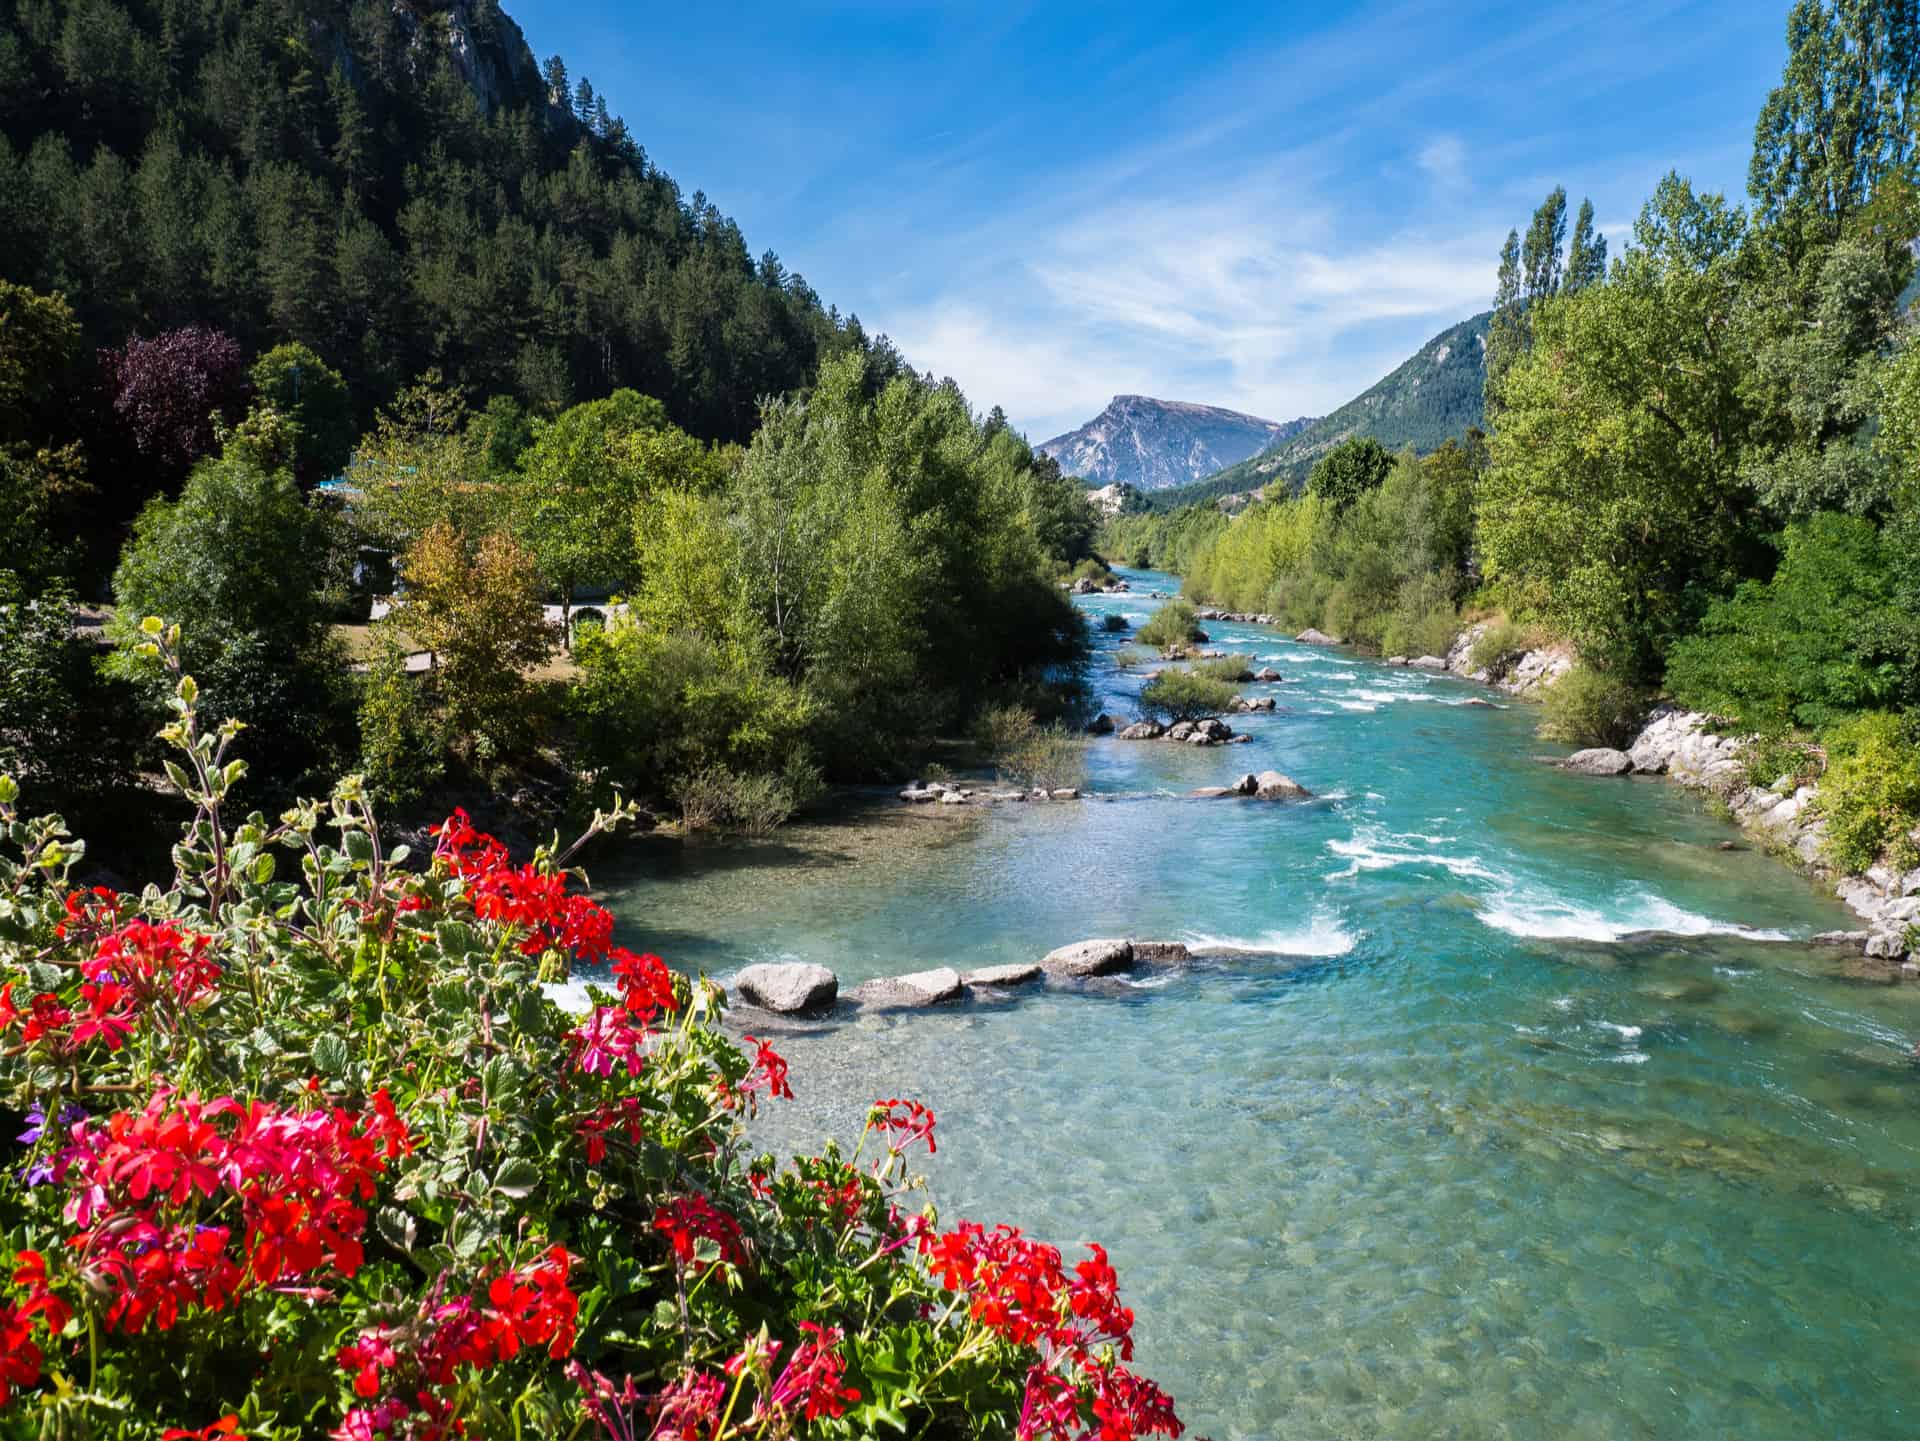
[1144,311,1494,509]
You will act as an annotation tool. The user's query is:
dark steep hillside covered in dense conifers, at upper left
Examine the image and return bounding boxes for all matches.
[0,0,897,440]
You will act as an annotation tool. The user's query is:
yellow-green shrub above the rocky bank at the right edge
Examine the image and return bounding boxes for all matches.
[1814,710,1920,872]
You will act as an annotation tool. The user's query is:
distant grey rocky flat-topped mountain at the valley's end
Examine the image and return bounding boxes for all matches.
[1035,396,1309,492]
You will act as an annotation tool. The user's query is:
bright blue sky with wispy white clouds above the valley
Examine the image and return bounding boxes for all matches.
[507,0,1788,440]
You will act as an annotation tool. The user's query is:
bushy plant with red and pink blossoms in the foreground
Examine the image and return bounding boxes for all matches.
[0,620,1181,1438]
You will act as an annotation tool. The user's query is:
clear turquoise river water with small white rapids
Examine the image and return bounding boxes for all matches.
[595,572,1920,1436]
